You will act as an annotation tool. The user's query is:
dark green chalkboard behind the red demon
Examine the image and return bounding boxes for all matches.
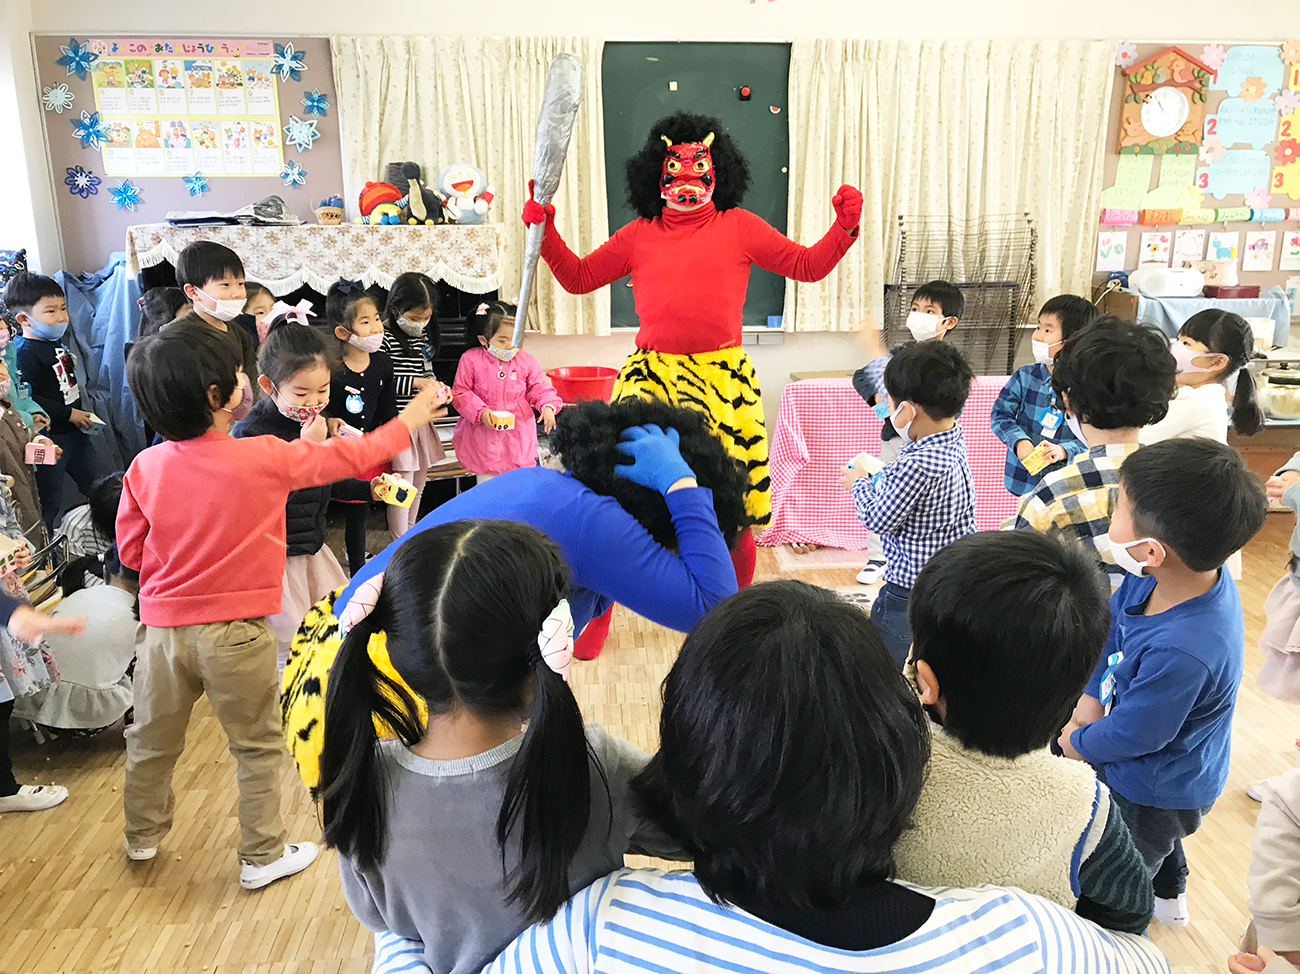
[601,42,790,328]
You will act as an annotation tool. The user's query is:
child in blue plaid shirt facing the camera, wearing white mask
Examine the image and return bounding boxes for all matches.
[989,294,1097,497]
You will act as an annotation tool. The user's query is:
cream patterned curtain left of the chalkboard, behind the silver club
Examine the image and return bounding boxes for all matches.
[330,36,610,334]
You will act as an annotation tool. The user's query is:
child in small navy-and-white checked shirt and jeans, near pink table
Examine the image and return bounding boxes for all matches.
[840,342,975,668]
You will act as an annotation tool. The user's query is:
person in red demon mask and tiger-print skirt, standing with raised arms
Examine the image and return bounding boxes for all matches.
[524,112,862,657]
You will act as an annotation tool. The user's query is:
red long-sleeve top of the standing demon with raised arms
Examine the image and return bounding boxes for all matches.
[542,203,857,355]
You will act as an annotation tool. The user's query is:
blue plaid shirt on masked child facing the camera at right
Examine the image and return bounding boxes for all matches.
[989,363,1088,497]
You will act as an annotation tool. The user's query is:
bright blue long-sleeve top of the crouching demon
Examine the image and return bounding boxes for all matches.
[335,467,736,632]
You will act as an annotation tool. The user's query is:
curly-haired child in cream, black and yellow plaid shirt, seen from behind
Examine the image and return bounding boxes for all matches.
[1015,315,1177,590]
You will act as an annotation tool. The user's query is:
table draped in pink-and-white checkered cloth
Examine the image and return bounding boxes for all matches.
[758,376,1019,551]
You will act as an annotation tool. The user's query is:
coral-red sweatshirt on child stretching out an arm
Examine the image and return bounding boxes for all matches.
[117,420,411,627]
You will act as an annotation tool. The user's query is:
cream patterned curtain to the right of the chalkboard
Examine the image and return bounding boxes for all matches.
[785,40,1115,332]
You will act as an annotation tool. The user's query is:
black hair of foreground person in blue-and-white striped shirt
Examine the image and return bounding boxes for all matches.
[633,581,930,910]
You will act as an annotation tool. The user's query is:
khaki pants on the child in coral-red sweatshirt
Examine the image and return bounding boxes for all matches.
[122,619,285,866]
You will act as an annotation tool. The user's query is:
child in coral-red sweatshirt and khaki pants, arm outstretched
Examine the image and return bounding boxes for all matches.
[117,318,438,889]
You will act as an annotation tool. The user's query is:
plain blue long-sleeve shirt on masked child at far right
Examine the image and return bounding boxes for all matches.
[1070,568,1245,809]
